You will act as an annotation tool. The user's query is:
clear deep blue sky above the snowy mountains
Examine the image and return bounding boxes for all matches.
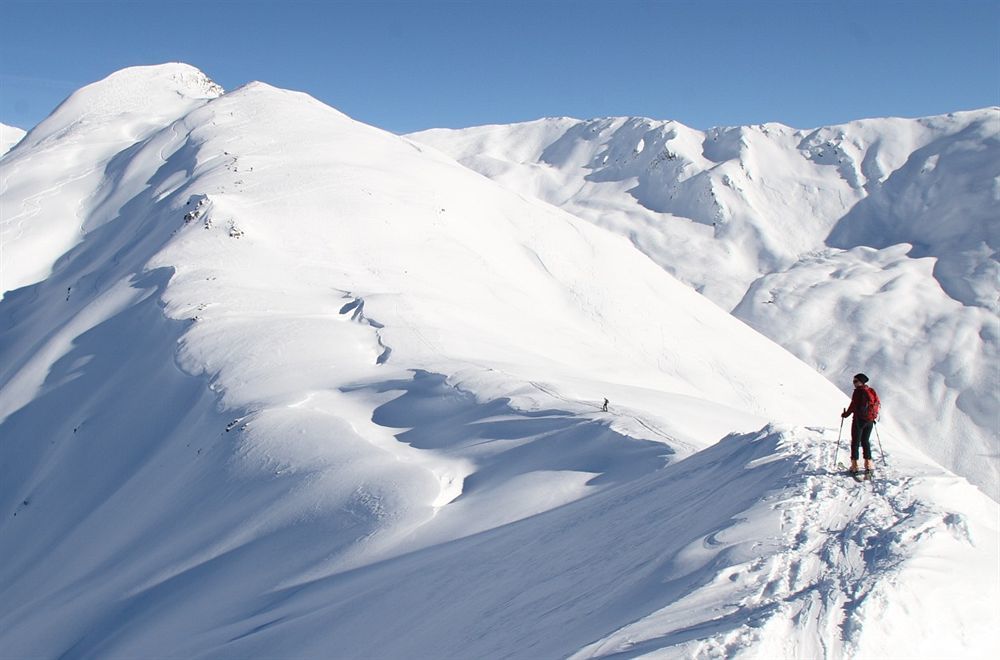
[0,0,1000,132]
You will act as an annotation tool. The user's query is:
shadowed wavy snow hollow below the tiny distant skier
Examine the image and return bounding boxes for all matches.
[346,370,687,548]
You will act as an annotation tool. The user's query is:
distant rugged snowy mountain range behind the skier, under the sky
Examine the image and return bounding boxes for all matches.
[412,108,1000,500]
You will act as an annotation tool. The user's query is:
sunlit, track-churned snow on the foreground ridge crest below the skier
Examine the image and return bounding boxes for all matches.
[573,428,996,658]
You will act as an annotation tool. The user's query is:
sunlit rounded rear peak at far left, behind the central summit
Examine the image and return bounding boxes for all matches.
[0,64,222,295]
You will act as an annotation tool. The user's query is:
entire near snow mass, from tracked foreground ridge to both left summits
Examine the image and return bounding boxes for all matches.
[0,65,1000,658]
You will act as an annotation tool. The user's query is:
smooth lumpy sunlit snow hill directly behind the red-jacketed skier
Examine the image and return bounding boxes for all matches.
[734,244,1000,499]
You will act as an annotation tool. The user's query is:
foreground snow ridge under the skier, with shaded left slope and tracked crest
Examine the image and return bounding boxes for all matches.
[199,427,997,658]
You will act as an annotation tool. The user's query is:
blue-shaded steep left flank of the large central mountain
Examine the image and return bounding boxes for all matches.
[0,164,352,657]
